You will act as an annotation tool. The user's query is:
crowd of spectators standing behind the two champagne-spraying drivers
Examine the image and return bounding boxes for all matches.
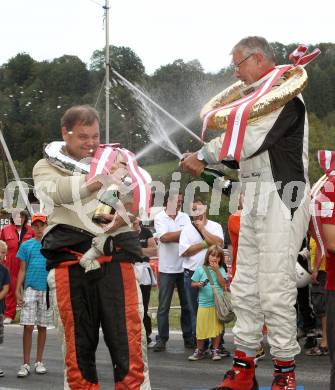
[0,188,329,386]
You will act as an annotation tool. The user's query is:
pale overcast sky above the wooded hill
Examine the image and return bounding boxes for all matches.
[0,0,335,74]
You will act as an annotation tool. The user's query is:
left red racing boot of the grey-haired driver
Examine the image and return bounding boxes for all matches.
[211,350,258,390]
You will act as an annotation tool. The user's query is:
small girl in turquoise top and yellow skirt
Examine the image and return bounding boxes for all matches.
[188,245,226,360]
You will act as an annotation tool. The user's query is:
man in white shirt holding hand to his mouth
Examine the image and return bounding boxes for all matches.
[179,199,223,346]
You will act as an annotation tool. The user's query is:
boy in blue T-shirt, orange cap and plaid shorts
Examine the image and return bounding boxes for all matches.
[16,213,52,378]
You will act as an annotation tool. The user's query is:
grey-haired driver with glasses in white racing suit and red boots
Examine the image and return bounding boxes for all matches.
[181,37,309,390]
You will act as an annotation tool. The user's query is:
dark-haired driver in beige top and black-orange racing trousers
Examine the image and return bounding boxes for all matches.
[33,105,150,390]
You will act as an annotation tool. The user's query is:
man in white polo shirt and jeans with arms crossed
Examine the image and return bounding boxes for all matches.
[154,191,194,352]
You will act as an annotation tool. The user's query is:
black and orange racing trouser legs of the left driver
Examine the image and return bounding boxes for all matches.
[48,261,150,390]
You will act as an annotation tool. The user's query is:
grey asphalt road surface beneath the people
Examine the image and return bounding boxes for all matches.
[0,325,329,390]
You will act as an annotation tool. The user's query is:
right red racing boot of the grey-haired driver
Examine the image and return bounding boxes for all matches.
[271,359,296,390]
